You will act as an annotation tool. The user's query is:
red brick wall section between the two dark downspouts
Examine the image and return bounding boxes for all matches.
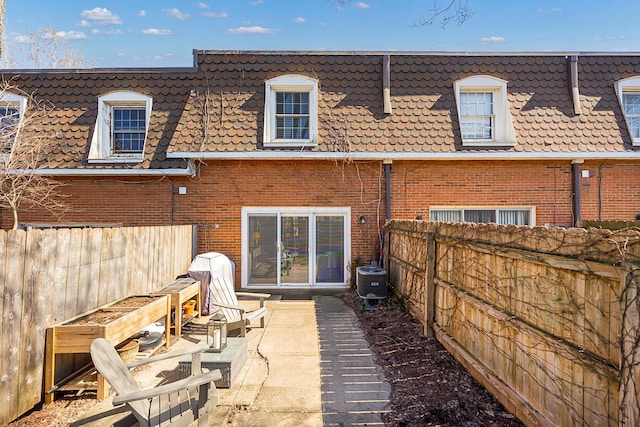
[391,161,572,225]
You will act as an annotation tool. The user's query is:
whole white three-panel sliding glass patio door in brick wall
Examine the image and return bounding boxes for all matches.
[242,208,350,288]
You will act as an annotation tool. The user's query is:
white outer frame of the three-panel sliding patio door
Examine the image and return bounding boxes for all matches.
[240,206,351,289]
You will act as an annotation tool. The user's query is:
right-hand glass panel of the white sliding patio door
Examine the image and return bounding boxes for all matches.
[315,215,344,283]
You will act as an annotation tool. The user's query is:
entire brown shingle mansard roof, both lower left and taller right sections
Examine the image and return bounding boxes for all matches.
[3,52,640,169]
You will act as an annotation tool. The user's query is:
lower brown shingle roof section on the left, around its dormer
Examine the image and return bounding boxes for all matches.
[2,71,194,169]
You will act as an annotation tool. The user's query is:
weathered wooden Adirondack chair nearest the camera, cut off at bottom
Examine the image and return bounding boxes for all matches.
[91,338,222,427]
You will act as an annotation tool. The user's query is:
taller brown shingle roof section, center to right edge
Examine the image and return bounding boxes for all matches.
[170,52,640,153]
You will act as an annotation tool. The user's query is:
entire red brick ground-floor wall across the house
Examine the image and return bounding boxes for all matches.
[8,160,640,280]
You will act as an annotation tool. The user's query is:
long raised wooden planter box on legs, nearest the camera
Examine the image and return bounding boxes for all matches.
[44,295,171,403]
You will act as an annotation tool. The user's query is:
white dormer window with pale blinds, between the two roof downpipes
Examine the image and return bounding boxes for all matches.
[453,76,516,147]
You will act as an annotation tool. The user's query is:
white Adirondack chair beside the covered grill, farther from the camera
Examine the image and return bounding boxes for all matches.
[209,276,271,337]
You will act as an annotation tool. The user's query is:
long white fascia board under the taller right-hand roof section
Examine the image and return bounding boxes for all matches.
[167,151,640,160]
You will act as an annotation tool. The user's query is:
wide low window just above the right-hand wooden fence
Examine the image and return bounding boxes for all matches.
[429,207,535,225]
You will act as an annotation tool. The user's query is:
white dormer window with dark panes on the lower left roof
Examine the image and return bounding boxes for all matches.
[89,91,152,163]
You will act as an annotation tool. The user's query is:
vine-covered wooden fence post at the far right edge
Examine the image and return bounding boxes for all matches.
[619,264,640,426]
